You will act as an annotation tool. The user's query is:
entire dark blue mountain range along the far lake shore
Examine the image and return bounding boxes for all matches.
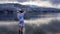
[0,3,60,12]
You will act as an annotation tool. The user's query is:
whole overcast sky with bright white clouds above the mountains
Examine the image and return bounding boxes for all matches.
[0,0,60,9]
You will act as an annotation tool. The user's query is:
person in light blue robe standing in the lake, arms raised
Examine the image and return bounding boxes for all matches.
[17,9,25,34]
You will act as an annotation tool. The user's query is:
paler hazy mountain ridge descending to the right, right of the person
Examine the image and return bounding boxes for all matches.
[27,5,60,12]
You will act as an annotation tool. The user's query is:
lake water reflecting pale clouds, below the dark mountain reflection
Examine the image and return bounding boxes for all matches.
[0,13,60,34]
